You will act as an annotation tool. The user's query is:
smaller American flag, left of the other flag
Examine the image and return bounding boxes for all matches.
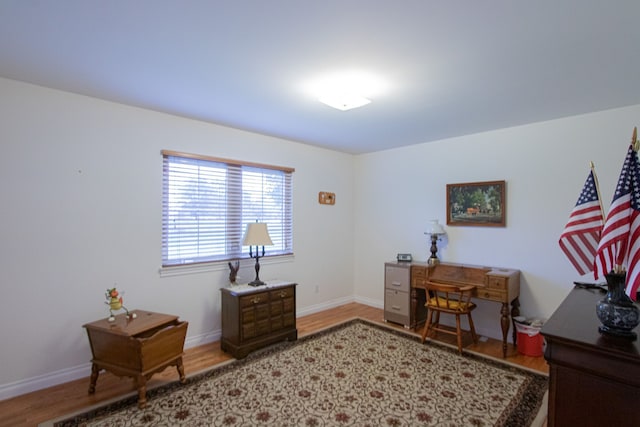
[558,170,603,274]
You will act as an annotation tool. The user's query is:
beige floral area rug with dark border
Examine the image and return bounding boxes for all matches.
[53,319,548,427]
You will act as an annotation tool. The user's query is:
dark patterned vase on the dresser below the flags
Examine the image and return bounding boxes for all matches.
[596,273,640,340]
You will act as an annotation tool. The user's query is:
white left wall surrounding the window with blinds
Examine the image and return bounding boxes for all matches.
[0,79,354,399]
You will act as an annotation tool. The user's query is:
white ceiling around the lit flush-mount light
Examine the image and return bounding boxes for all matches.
[0,0,640,153]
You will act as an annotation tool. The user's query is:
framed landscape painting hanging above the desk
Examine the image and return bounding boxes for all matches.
[447,181,505,227]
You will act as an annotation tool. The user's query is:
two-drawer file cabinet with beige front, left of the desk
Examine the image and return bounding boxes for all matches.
[384,262,426,328]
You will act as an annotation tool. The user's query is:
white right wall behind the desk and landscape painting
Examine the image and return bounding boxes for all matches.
[354,105,640,338]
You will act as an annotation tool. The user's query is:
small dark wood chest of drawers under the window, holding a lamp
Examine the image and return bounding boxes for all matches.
[220,282,298,359]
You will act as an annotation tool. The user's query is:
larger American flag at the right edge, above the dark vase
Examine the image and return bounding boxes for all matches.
[594,144,640,300]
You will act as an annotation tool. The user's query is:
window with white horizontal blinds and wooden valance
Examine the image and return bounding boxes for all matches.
[162,151,294,267]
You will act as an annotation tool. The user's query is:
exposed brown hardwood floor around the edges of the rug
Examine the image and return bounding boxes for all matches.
[0,303,549,427]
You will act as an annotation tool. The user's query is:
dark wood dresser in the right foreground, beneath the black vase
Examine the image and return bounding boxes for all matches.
[541,288,640,427]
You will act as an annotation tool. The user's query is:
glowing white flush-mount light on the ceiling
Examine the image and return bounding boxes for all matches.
[305,71,386,111]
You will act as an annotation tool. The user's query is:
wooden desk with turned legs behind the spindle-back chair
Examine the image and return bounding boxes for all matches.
[411,262,520,357]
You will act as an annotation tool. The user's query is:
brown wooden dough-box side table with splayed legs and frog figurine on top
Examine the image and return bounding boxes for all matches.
[83,310,188,408]
